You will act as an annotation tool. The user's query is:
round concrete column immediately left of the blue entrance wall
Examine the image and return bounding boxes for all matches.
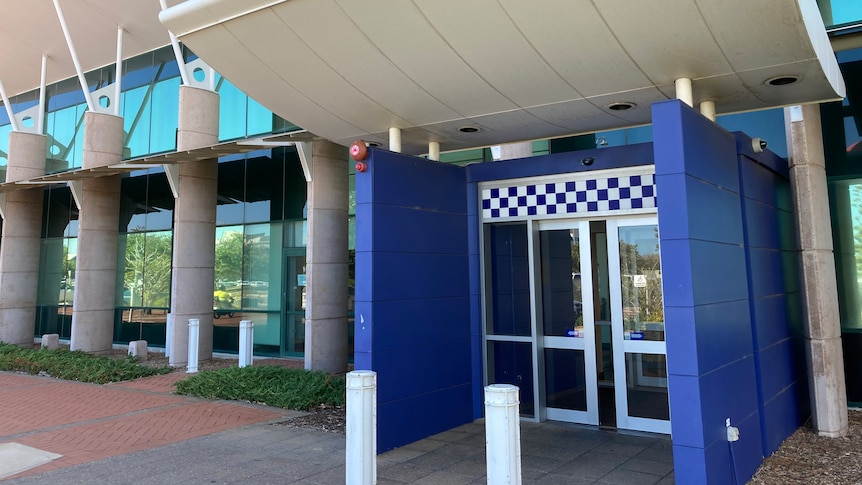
[305,140,348,374]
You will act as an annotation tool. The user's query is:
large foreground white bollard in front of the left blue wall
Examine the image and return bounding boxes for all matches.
[345,370,377,485]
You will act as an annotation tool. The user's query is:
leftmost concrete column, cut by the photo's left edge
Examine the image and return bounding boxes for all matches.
[0,132,46,346]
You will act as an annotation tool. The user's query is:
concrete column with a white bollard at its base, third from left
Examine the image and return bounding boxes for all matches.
[167,86,219,367]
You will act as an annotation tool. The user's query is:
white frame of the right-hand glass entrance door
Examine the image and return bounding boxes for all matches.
[606,214,671,434]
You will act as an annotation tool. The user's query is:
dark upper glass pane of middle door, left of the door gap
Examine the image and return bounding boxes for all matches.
[539,229,584,338]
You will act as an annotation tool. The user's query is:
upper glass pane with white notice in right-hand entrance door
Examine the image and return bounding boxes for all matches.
[619,225,665,341]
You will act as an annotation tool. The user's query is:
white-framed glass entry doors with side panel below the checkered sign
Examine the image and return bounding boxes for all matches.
[484,216,670,433]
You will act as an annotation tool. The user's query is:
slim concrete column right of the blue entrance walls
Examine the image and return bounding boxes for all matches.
[785,104,848,437]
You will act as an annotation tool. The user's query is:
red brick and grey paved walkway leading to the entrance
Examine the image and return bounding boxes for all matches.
[0,372,673,485]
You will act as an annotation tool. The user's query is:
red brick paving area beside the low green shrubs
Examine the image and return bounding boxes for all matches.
[0,372,295,477]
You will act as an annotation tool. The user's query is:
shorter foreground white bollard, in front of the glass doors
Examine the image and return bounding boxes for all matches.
[485,384,521,485]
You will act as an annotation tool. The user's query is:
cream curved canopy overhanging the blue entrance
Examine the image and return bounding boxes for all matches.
[161,0,844,153]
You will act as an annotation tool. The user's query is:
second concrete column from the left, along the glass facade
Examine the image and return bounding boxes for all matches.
[71,112,123,352]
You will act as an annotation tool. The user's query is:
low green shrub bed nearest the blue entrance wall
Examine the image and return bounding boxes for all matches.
[177,366,344,411]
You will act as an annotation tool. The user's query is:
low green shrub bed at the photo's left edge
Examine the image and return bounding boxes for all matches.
[0,342,171,384]
